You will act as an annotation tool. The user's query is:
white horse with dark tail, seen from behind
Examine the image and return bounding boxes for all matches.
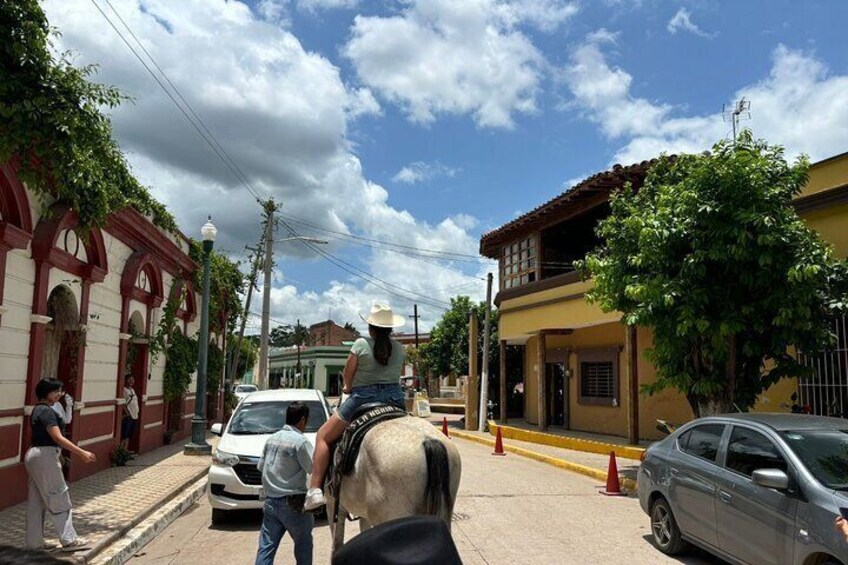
[327,416,462,552]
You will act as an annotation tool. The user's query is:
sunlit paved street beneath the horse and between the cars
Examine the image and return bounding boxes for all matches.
[130,439,722,565]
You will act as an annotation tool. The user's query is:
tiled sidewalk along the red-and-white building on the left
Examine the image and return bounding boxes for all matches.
[0,438,212,562]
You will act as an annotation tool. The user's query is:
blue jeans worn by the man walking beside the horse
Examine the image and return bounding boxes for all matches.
[256,498,315,565]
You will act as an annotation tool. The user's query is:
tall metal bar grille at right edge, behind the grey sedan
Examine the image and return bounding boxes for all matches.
[798,316,848,418]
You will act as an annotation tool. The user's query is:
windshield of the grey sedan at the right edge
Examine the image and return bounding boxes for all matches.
[781,430,848,490]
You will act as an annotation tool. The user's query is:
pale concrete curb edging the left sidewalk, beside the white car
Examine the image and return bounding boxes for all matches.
[87,476,206,565]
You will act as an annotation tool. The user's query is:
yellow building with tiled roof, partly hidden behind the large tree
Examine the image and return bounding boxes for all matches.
[480,153,848,442]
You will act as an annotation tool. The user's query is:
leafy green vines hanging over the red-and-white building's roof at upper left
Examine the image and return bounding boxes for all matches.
[0,0,177,233]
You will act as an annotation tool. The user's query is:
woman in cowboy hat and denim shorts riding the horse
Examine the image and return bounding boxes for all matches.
[304,304,406,510]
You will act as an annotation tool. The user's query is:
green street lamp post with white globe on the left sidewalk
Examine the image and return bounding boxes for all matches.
[185,216,218,455]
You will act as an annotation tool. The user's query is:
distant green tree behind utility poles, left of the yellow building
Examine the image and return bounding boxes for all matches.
[419,296,499,376]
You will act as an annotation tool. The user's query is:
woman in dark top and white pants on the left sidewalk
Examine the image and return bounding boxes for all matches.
[24,379,96,551]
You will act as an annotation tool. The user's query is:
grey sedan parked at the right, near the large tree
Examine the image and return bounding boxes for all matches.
[637,413,848,565]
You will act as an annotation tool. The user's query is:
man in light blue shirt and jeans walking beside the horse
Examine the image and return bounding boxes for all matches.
[256,402,315,565]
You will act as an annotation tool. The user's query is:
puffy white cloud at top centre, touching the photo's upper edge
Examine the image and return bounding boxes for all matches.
[343,0,577,128]
